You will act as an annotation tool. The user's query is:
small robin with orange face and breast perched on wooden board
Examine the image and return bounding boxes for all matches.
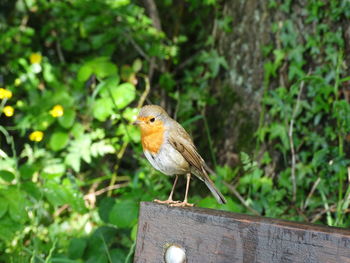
[134,105,226,206]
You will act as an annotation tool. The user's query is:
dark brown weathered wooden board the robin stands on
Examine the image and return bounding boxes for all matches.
[134,202,350,263]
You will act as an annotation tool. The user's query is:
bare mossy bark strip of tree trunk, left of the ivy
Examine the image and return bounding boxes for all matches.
[209,0,273,165]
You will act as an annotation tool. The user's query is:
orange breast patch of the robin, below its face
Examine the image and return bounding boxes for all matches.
[141,121,165,154]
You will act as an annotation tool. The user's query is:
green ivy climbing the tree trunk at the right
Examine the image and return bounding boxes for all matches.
[252,1,350,226]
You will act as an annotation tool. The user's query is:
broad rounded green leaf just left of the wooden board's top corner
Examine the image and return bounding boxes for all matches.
[109,200,138,228]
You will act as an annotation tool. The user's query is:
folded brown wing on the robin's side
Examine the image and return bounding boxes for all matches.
[169,123,205,173]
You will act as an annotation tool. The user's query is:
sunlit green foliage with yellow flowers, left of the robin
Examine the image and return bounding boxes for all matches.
[0,0,228,262]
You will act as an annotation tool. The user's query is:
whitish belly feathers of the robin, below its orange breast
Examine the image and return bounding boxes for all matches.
[143,142,190,175]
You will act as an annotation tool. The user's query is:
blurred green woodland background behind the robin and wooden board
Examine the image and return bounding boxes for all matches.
[0,0,350,263]
